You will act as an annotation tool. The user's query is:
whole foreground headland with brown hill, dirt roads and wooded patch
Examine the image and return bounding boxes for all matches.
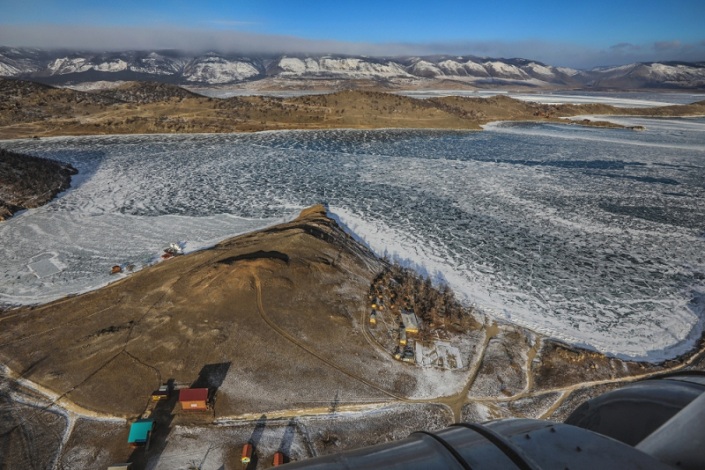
[0,206,705,468]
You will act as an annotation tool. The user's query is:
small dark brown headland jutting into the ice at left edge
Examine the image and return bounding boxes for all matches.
[0,149,77,220]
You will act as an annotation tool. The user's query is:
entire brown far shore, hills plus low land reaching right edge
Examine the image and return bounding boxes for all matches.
[0,79,705,138]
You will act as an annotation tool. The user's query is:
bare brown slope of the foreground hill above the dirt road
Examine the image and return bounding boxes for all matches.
[0,207,414,416]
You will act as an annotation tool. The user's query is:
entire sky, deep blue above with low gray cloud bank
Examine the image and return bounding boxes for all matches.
[0,0,705,67]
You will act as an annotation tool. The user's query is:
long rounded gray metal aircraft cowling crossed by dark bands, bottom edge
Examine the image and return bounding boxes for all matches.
[276,419,672,470]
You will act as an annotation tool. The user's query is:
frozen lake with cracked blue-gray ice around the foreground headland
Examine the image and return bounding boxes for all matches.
[0,114,705,360]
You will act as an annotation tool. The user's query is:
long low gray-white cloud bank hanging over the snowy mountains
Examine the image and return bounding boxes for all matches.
[0,25,705,68]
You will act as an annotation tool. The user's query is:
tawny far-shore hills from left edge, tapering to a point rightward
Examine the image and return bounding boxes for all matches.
[0,80,477,138]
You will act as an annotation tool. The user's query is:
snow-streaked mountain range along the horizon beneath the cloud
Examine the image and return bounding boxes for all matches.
[0,47,705,89]
